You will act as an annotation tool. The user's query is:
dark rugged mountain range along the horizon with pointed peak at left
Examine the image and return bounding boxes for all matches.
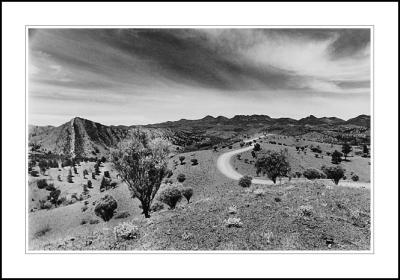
[28,115,371,157]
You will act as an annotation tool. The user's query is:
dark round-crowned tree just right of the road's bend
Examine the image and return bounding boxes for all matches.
[255,150,290,184]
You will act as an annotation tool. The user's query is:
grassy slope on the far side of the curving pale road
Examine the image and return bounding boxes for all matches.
[231,136,370,182]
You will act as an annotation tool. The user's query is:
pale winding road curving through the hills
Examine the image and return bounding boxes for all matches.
[217,134,370,189]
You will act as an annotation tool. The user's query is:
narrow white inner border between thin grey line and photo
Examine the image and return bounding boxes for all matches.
[25,25,374,254]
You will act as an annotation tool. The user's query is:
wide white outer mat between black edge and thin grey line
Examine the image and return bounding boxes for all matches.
[2,2,398,278]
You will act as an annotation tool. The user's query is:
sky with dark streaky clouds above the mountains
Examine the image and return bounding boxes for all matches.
[28,28,371,125]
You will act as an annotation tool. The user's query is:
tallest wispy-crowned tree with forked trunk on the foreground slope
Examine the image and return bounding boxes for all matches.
[111,130,170,218]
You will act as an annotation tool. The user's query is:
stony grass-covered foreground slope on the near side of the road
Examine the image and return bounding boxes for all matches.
[29,143,370,250]
